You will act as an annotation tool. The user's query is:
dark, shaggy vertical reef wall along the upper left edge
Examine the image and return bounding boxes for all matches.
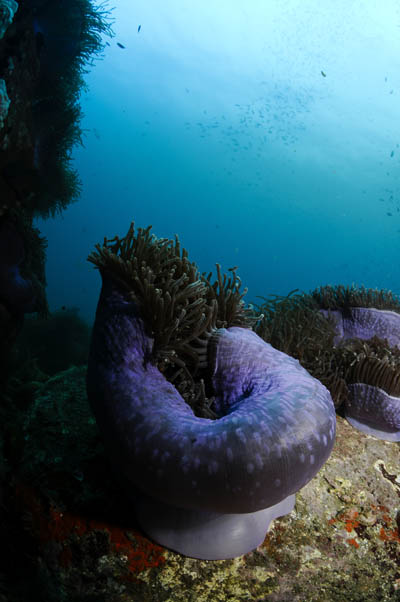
[0,0,111,382]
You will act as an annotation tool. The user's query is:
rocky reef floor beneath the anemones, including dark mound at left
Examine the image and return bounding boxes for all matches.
[0,368,400,602]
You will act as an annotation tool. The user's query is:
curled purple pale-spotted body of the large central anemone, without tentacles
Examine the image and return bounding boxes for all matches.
[87,272,336,560]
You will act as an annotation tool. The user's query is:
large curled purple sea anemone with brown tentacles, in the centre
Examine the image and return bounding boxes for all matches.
[87,225,336,559]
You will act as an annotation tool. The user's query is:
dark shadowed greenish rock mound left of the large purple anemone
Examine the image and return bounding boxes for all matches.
[20,366,114,511]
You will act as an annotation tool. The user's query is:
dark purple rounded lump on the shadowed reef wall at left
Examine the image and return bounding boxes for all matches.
[0,219,36,314]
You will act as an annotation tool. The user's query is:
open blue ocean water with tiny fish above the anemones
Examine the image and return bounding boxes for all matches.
[33,0,400,322]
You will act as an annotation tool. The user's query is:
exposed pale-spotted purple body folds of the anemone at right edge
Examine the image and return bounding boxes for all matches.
[320,307,400,441]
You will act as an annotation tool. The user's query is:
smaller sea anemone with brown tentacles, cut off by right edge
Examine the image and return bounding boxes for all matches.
[256,285,400,441]
